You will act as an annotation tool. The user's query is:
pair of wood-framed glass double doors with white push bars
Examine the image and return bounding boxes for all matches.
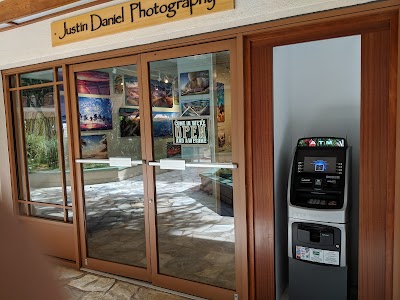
[70,41,248,300]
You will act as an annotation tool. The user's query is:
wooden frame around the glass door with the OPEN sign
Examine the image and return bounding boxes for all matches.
[141,39,248,300]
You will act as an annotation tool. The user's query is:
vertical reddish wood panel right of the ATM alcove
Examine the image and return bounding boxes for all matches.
[359,30,395,299]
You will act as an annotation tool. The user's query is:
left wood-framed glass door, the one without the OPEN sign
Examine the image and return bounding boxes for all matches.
[72,57,150,281]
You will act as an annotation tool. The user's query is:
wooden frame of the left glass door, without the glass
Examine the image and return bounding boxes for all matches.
[69,55,151,281]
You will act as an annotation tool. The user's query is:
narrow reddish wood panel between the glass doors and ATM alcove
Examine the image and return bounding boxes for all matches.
[247,47,275,299]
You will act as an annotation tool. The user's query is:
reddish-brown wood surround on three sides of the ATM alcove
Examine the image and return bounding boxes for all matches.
[246,10,398,300]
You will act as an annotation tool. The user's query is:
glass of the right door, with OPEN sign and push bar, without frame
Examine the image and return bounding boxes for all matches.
[149,51,236,290]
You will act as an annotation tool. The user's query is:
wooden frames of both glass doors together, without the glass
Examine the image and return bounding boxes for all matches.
[69,39,248,300]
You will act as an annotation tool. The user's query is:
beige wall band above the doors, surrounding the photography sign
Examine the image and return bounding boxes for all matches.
[0,0,374,69]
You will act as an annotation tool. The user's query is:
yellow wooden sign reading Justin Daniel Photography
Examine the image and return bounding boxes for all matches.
[51,0,235,47]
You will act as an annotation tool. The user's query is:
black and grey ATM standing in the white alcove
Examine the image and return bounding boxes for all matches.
[287,137,351,300]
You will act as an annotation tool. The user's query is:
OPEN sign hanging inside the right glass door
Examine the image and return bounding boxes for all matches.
[172,117,209,145]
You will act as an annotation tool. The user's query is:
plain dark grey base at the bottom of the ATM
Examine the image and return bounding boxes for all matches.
[289,258,348,300]
